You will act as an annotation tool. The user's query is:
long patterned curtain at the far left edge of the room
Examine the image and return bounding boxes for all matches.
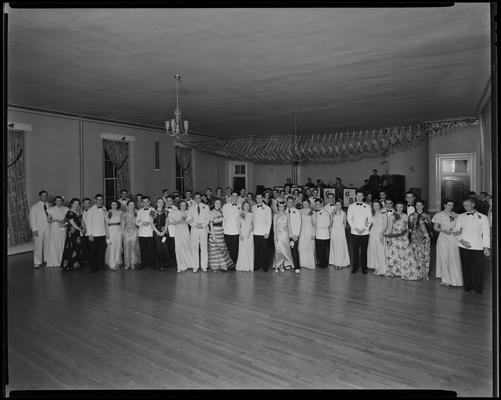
[7,129,33,246]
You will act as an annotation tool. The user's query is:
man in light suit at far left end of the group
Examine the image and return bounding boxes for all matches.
[29,190,49,268]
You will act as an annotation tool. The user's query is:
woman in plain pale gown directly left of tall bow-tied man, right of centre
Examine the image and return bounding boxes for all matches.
[329,200,350,269]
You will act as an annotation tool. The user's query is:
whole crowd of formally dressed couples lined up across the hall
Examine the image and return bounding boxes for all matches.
[29,172,492,293]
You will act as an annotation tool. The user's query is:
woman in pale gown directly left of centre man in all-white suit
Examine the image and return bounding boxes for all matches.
[170,200,192,272]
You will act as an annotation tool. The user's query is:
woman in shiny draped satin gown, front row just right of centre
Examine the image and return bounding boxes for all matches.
[273,200,295,272]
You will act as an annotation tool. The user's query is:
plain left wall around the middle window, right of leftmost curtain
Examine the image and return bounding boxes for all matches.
[8,109,175,204]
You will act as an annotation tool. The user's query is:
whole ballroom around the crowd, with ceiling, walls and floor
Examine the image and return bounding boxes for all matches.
[4,3,498,396]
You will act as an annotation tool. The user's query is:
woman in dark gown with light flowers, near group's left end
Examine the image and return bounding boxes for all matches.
[61,198,84,271]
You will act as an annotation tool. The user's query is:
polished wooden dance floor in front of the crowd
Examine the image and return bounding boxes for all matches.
[7,253,492,396]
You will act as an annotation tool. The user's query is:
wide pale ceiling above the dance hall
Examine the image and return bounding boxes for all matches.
[8,4,490,135]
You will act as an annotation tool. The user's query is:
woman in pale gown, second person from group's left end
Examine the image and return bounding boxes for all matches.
[47,196,68,267]
